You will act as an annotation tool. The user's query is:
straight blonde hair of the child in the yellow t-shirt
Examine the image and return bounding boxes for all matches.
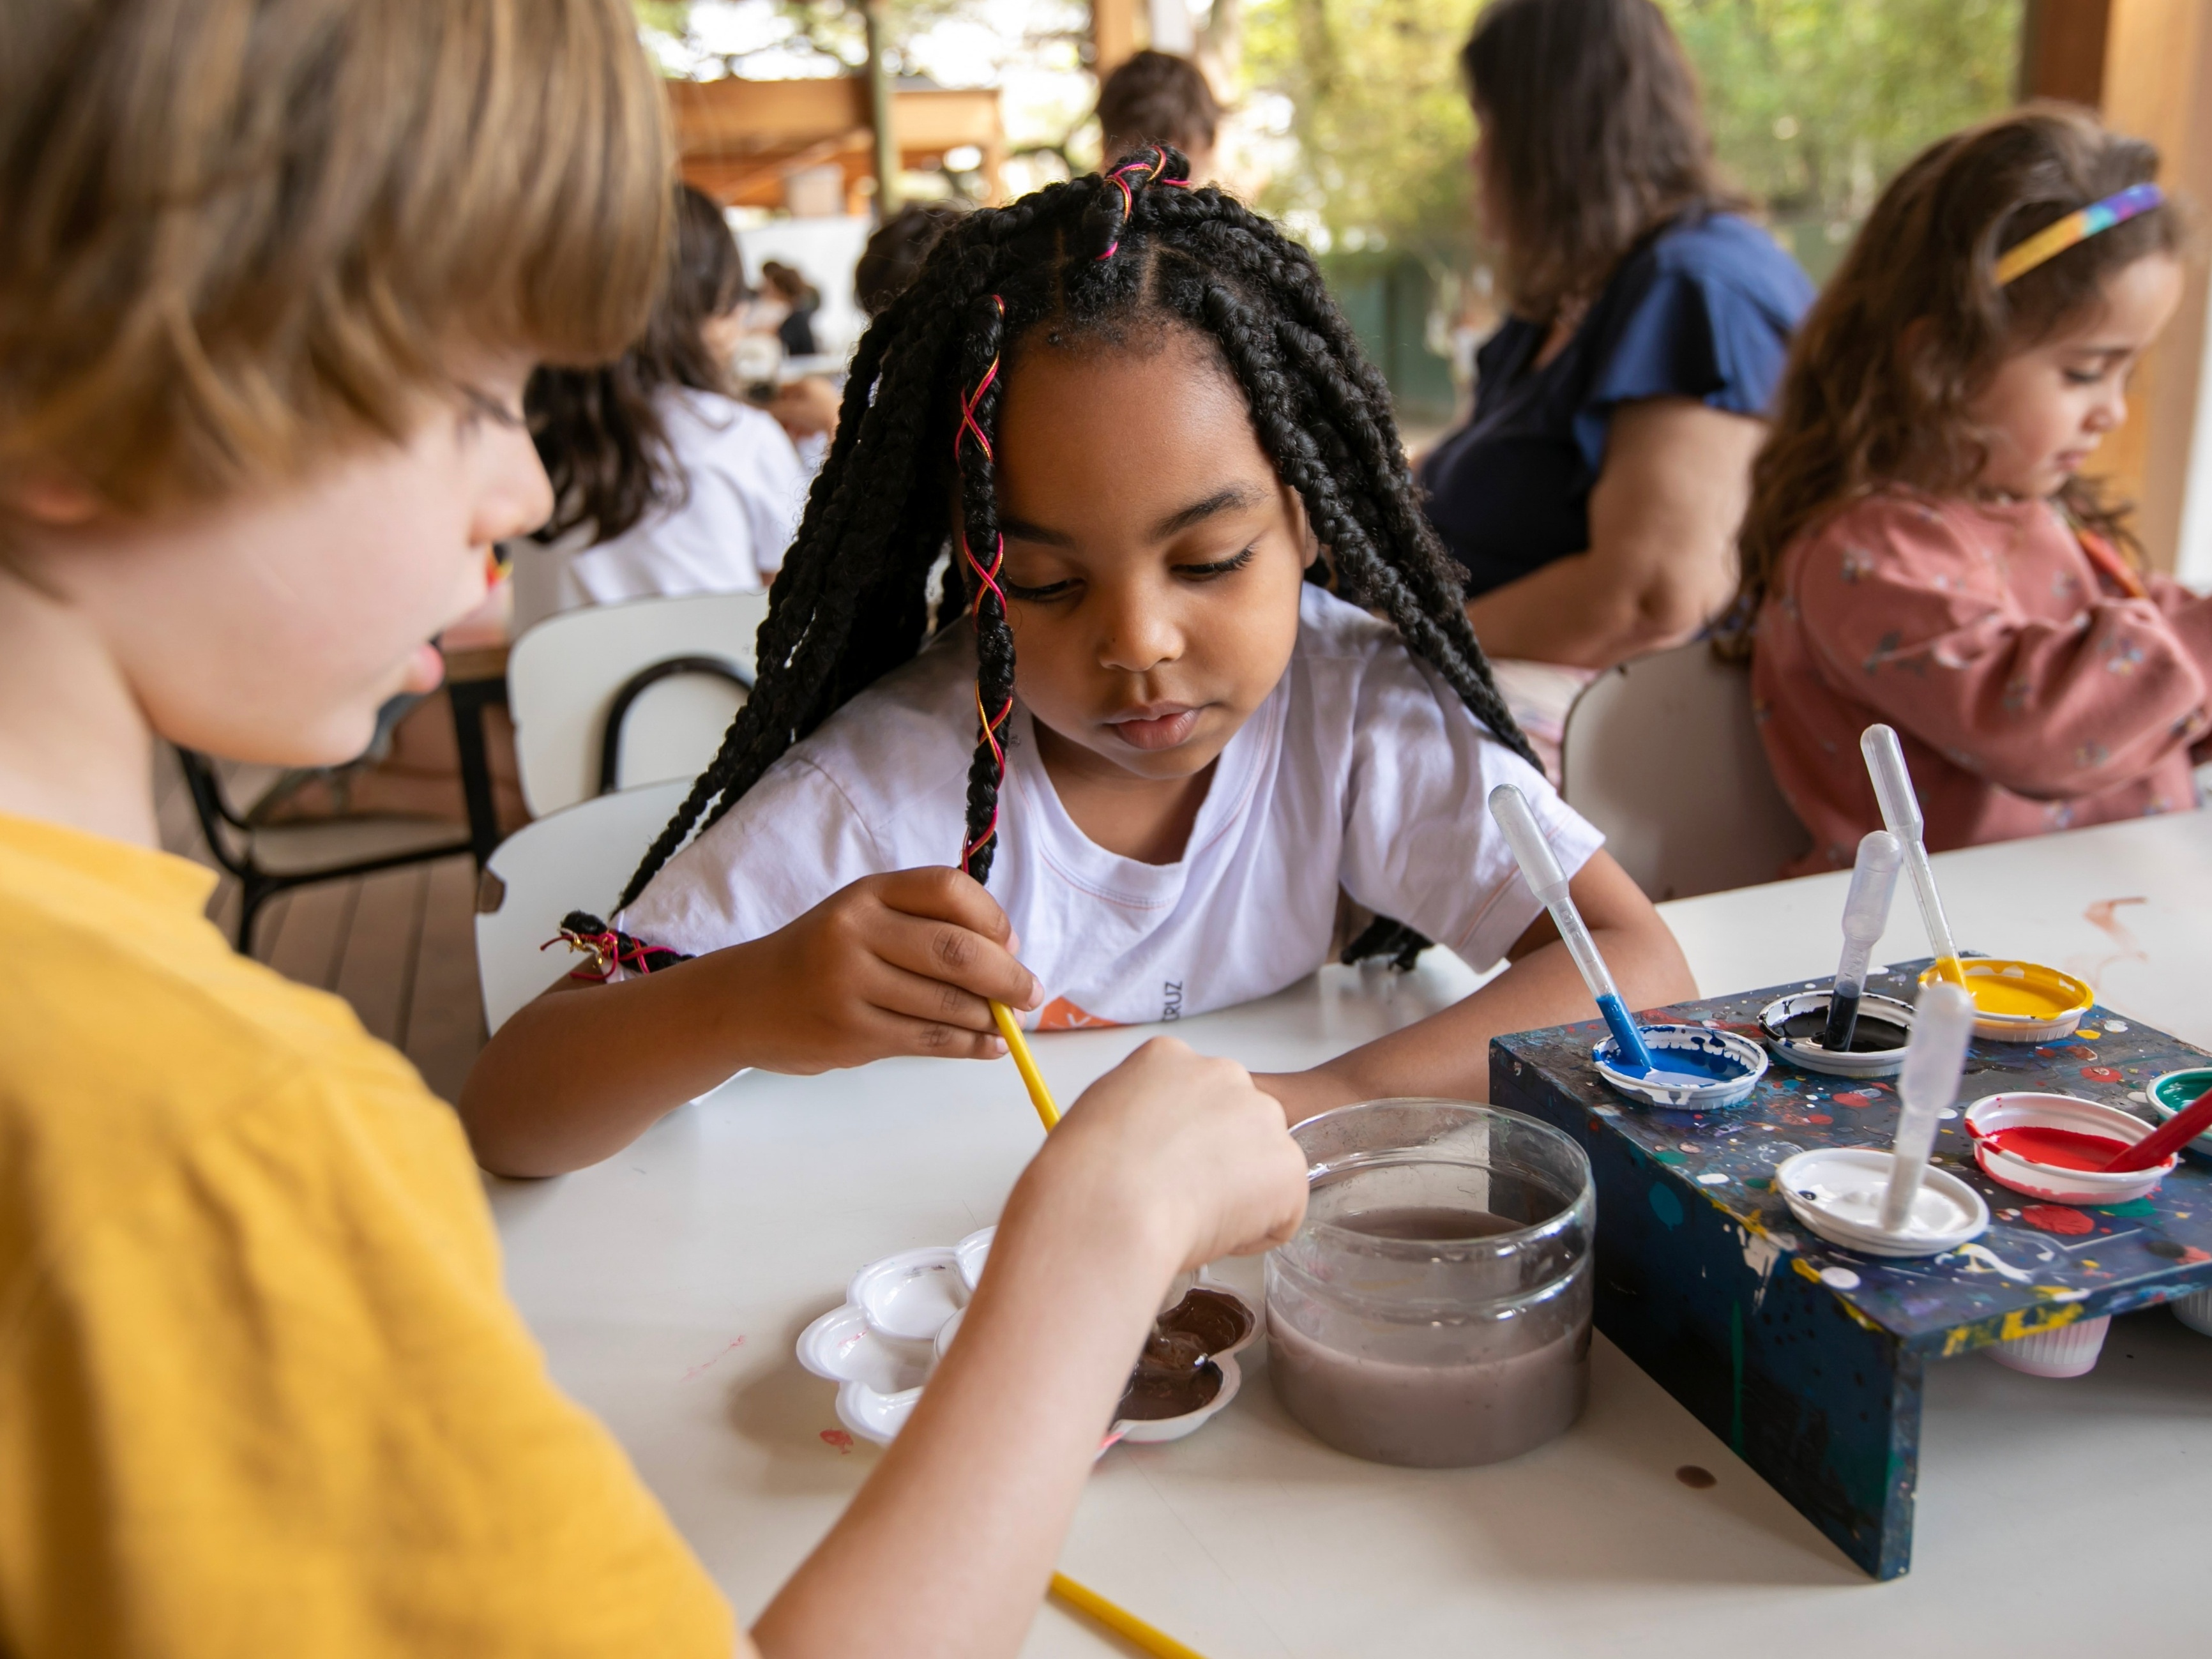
[0,0,670,511]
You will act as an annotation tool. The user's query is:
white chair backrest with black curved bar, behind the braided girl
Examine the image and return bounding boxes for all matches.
[506,593,768,816]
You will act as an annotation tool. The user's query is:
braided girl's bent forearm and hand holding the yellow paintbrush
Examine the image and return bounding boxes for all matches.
[460,869,1042,1174]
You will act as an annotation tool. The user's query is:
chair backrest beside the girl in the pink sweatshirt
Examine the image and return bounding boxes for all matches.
[1559,639,1812,900]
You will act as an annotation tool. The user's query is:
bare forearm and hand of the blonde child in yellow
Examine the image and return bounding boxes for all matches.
[752,1038,1305,1659]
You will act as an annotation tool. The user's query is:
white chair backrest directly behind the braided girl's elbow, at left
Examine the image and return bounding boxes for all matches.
[476,778,690,1031]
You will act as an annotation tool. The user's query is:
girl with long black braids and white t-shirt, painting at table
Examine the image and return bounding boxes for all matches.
[460,148,1694,1174]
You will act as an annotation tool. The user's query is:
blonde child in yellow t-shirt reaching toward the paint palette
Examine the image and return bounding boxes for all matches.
[0,0,1303,1659]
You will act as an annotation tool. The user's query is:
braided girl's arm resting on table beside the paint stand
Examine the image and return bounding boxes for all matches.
[1259,852,1697,1124]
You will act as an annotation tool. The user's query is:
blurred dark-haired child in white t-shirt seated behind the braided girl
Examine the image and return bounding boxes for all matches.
[515,184,807,630]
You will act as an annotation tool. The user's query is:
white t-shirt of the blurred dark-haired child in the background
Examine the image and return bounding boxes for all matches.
[513,387,812,633]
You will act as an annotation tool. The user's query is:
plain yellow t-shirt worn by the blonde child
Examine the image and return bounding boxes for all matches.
[0,816,737,1659]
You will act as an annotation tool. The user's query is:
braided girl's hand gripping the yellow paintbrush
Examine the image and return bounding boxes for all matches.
[725,869,1042,1075]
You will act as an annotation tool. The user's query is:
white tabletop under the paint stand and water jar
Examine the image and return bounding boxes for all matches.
[491,812,2212,1659]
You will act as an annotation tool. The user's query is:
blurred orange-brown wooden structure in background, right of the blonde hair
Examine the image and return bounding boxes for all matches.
[666,75,1006,208]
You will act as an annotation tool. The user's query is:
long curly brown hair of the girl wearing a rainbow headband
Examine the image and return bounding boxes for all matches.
[1723,104,2183,655]
